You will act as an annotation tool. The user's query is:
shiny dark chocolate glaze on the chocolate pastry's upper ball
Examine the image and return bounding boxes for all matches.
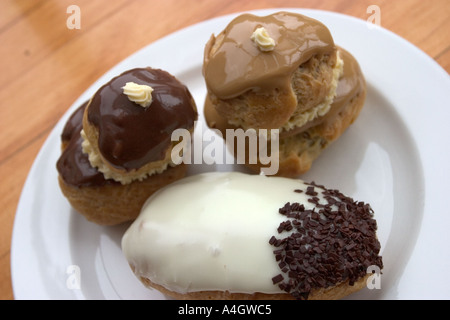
[87,68,198,171]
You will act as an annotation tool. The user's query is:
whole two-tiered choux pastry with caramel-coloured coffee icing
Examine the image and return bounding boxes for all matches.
[203,12,366,177]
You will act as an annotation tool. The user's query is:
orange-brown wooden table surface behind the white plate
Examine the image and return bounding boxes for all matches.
[0,0,450,299]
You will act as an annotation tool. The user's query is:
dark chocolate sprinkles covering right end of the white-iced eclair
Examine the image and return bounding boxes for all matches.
[269,182,383,300]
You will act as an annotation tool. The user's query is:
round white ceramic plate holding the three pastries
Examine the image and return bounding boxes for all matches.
[11,9,450,299]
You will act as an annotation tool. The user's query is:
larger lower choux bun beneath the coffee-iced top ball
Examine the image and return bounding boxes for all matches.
[204,47,366,177]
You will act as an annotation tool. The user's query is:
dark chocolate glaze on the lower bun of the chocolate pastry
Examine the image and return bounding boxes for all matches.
[56,101,120,187]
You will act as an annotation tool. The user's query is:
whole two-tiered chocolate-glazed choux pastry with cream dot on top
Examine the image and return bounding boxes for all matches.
[57,68,198,225]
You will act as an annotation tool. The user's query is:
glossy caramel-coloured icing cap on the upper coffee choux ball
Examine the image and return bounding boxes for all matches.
[203,12,335,99]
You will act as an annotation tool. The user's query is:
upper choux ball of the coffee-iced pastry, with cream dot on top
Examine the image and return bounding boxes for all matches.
[203,12,342,131]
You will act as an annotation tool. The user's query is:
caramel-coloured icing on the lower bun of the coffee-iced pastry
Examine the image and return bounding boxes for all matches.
[204,47,366,138]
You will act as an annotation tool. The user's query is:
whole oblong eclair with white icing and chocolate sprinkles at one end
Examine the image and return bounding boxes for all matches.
[122,172,383,300]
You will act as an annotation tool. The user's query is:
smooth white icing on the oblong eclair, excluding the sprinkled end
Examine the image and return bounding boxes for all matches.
[122,172,321,293]
